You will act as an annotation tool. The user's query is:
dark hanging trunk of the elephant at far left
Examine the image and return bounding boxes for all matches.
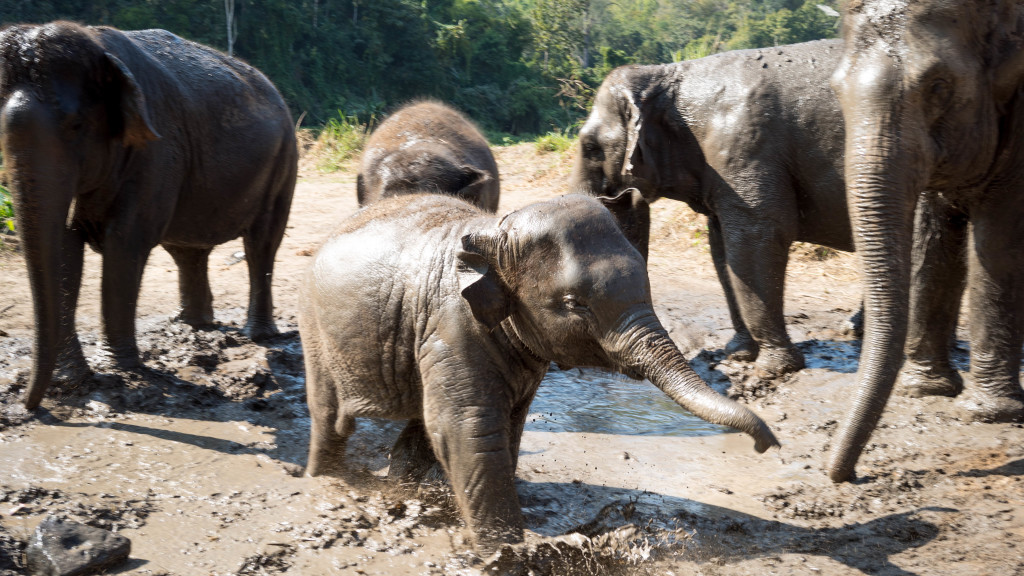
[0,88,81,410]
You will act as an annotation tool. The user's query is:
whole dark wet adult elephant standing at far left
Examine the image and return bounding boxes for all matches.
[0,22,297,408]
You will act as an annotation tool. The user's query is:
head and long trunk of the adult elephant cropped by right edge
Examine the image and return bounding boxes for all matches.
[829,0,1024,482]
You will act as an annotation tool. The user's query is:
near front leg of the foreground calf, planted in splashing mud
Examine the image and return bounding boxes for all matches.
[426,400,524,556]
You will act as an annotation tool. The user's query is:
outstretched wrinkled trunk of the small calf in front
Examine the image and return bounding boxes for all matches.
[615,311,780,452]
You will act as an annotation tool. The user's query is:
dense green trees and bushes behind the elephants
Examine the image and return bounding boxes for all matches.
[0,0,837,133]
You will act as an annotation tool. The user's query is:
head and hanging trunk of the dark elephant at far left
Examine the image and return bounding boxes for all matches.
[0,22,160,408]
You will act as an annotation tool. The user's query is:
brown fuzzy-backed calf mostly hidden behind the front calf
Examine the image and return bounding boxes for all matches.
[355,101,501,212]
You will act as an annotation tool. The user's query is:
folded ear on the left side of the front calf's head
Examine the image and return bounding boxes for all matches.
[456,231,512,330]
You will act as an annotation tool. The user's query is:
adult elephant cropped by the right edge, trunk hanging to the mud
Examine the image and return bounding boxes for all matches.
[828,0,1024,482]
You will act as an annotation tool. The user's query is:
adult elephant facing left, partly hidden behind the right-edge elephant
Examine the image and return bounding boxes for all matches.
[570,40,853,375]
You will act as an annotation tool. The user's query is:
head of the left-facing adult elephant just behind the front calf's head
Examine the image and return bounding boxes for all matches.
[569,66,699,259]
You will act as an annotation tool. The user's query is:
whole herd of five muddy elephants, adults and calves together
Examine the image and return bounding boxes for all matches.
[0,0,1024,552]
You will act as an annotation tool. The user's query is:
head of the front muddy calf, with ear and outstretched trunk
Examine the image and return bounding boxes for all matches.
[458,195,778,452]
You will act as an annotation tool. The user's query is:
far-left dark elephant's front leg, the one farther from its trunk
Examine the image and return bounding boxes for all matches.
[100,230,155,369]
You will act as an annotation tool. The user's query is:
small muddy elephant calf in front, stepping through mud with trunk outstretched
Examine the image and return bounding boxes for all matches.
[299,194,779,553]
